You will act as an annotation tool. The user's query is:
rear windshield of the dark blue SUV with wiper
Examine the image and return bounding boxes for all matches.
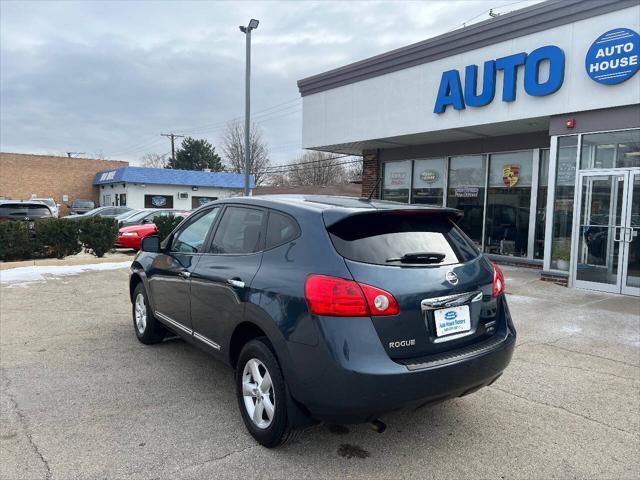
[328,213,479,266]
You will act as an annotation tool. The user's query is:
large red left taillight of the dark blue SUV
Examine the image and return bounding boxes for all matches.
[304,275,400,317]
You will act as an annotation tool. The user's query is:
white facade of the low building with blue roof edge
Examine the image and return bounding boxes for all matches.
[98,183,242,210]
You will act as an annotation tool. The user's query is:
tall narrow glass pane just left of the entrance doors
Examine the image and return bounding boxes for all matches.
[551,136,578,271]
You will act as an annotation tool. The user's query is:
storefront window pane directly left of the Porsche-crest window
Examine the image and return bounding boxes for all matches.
[447,155,487,245]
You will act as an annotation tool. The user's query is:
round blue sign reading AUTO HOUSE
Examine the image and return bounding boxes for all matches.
[584,28,640,85]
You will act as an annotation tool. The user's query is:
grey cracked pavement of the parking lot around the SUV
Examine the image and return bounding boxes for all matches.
[0,267,640,479]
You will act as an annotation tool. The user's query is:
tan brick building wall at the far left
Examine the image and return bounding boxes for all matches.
[0,153,129,216]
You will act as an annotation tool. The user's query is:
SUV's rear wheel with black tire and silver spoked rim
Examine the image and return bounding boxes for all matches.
[236,337,296,448]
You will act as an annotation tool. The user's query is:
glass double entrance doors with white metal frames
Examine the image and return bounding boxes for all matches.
[572,169,640,295]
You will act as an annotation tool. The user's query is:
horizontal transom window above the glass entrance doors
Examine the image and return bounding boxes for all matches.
[580,130,640,170]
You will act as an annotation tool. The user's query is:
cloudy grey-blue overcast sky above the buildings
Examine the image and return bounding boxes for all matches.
[0,0,538,164]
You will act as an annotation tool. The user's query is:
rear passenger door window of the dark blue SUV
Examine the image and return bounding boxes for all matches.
[211,207,265,254]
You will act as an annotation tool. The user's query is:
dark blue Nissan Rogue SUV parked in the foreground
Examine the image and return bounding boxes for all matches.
[129,196,516,447]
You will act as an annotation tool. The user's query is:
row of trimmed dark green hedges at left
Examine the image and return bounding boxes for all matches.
[0,217,118,261]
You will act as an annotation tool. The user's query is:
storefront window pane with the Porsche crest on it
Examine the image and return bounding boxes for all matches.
[484,150,533,257]
